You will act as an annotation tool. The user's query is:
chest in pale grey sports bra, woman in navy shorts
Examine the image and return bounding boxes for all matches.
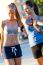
[4,23,18,34]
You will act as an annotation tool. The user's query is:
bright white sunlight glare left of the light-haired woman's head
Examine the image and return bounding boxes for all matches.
[0,0,14,32]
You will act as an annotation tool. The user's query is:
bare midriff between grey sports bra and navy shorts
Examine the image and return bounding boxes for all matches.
[3,34,18,46]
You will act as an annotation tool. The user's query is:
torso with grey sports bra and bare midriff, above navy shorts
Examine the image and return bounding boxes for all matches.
[1,20,18,44]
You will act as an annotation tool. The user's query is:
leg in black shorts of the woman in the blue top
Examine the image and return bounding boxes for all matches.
[32,44,43,65]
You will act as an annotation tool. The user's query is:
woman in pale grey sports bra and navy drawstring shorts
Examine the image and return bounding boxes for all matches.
[1,3,25,65]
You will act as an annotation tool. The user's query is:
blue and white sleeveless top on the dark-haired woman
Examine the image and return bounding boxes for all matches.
[26,16,43,47]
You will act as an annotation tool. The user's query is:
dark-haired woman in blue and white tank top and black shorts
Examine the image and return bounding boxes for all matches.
[25,1,43,65]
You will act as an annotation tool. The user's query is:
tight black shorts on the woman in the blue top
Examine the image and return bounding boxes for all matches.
[32,45,42,59]
